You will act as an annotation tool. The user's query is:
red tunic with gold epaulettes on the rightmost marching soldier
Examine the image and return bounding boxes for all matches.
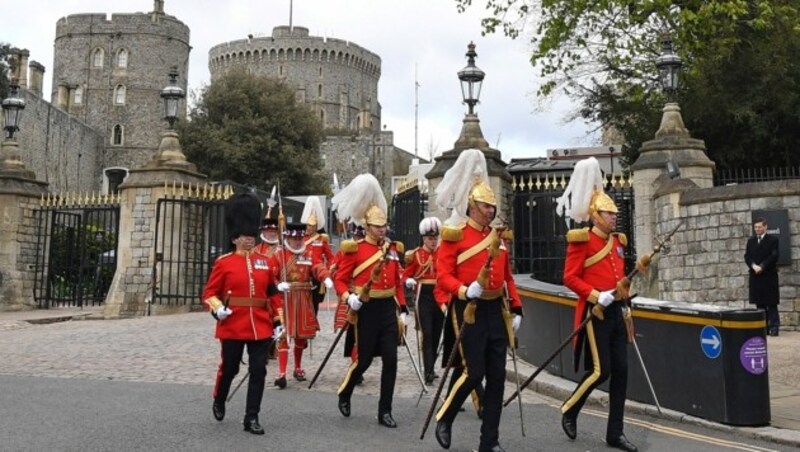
[564,227,628,327]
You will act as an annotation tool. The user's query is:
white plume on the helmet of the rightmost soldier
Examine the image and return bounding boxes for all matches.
[556,157,603,222]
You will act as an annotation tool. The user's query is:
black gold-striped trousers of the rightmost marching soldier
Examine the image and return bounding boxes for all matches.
[561,301,628,439]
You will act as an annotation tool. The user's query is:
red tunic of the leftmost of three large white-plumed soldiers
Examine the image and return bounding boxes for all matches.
[334,237,406,310]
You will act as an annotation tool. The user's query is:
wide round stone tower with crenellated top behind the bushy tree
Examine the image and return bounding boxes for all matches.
[208,26,381,132]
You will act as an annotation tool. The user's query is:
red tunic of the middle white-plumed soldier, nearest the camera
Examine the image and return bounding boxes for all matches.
[436,219,522,312]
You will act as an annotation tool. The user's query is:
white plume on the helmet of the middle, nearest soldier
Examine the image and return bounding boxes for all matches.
[436,149,489,226]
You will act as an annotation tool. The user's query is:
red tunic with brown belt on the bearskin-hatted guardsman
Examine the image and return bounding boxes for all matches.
[202,252,282,341]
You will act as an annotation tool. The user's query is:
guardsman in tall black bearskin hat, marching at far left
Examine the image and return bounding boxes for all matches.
[202,193,282,435]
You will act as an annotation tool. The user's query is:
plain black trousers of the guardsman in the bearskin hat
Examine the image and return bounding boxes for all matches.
[214,339,271,422]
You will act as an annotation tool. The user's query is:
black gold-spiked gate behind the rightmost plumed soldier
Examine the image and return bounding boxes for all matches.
[513,175,636,284]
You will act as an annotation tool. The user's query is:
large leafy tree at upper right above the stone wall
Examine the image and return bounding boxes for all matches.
[456,0,800,167]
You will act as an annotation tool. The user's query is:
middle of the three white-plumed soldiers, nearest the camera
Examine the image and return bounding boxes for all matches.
[436,149,522,452]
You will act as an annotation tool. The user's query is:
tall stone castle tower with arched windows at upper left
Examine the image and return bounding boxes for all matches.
[52,0,191,190]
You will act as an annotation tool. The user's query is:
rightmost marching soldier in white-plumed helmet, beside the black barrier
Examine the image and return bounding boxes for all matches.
[556,157,637,451]
